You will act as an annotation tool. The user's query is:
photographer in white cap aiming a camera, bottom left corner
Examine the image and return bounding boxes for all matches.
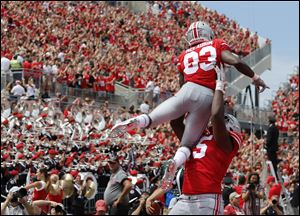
[1,187,28,215]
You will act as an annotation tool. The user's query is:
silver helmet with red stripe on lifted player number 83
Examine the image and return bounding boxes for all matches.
[186,21,214,46]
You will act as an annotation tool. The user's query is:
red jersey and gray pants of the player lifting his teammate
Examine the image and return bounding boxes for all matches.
[169,130,242,215]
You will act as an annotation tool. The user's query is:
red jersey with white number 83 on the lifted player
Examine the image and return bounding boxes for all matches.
[177,39,231,90]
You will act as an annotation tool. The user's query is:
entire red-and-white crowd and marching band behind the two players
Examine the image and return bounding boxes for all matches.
[1,1,299,214]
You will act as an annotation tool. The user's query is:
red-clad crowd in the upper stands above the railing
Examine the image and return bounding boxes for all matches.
[1,1,264,94]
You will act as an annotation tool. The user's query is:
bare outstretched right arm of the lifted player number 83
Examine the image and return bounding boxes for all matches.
[221,50,269,92]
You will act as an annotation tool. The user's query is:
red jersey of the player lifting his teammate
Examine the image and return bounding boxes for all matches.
[182,130,242,195]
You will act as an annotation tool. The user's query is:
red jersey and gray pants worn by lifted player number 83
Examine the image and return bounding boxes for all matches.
[149,39,230,148]
